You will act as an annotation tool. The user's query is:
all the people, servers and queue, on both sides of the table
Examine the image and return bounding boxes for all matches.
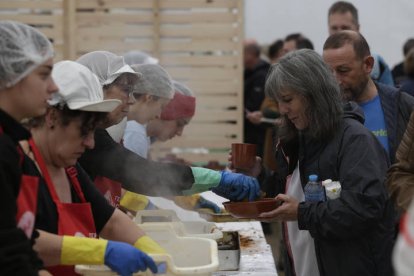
[0,1,414,276]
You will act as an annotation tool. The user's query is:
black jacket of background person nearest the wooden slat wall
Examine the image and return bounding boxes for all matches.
[244,60,270,156]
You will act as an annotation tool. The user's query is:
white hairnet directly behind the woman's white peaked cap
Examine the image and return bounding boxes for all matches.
[76,51,139,86]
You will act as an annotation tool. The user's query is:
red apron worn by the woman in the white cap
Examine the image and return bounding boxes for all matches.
[29,139,97,276]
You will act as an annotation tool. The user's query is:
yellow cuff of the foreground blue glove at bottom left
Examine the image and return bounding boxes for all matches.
[60,236,108,265]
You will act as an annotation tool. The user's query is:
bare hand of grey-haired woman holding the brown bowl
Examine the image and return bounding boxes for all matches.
[259,194,299,222]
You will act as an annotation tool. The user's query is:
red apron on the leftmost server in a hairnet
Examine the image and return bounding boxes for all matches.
[0,126,39,239]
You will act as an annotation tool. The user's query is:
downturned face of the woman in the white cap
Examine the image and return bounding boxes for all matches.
[48,115,95,167]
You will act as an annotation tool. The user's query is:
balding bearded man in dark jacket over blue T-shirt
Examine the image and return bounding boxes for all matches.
[323,31,414,163]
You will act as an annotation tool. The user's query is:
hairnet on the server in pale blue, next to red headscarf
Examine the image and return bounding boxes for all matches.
[131,64,174,99]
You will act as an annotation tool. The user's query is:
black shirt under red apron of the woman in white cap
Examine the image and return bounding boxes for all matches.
[32,163,115,234]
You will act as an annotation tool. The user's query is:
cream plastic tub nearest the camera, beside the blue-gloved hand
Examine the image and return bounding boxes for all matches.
[75,224,219,276]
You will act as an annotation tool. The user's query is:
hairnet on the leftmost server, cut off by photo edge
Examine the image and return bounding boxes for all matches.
[0,21,53,89]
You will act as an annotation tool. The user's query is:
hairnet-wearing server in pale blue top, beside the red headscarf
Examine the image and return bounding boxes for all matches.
[123,64,174,158]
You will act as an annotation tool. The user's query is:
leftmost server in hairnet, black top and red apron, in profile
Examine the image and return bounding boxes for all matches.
[0,21,57,275]
